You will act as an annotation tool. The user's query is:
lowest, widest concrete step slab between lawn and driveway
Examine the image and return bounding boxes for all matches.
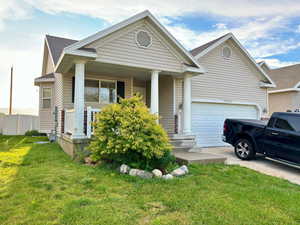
[174,151,226,164]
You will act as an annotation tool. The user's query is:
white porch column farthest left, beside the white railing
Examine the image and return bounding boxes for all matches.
[72,61,85,139]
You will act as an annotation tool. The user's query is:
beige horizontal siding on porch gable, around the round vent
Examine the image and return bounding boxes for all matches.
[88,20,185,72]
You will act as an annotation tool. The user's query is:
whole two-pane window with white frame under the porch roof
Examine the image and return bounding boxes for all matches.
[84,80,117,104]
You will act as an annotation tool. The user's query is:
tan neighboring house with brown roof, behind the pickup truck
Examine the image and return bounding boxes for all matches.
[266,64,300,115]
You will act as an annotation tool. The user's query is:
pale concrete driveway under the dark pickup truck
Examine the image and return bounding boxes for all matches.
[201,147,300,185]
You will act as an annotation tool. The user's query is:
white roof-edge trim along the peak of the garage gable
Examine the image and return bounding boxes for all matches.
[195,33,276,88]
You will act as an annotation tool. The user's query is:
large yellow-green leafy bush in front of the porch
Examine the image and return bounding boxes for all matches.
[89,96,174,169]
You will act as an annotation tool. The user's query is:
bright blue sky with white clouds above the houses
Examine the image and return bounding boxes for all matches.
[0,0,300,114]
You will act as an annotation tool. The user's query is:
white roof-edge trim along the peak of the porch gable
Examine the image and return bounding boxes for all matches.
[62,10,204,73]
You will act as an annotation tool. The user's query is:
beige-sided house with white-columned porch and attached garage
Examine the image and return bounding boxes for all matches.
[35,11,274,153]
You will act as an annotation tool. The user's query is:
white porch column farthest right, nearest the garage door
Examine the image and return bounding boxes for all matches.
[183,74,192,134]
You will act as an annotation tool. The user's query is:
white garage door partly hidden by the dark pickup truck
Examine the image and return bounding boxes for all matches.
[192,103,258,147]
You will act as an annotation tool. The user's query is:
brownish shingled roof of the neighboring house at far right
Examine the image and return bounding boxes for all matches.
[268,64,300,90]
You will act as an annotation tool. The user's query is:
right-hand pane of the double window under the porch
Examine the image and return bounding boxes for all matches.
[100,81,117,104]
